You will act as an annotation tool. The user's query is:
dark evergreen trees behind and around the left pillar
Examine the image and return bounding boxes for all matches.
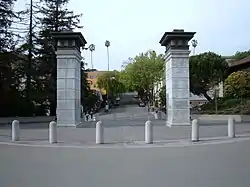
[0,0,94,116]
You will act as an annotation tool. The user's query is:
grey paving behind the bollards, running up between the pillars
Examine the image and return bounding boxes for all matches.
[0,106,250,144]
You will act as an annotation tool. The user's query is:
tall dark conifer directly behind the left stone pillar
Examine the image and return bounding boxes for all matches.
[39,0,81,115]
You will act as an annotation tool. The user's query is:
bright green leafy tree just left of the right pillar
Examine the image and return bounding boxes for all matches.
[123,51,165,104]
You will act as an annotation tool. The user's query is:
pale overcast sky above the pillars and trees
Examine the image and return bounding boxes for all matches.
[15,0,250,70]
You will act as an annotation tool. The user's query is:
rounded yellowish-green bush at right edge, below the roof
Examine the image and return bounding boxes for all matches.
[224,71,250,99]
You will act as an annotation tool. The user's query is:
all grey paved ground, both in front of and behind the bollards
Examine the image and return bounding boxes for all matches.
[0,107,250,187]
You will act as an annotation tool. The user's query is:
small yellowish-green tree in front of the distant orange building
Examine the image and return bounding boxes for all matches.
[97,71,126,99]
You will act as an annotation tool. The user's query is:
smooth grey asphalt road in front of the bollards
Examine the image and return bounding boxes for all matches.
[0,141,250,187]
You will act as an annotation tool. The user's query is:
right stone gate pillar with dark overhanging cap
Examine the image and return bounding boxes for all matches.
[160,30,195,127]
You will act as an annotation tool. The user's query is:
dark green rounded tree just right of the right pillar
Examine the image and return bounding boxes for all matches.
[189,52,228,101]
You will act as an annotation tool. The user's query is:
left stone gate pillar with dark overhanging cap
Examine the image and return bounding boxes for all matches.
[52,31,87,127]
